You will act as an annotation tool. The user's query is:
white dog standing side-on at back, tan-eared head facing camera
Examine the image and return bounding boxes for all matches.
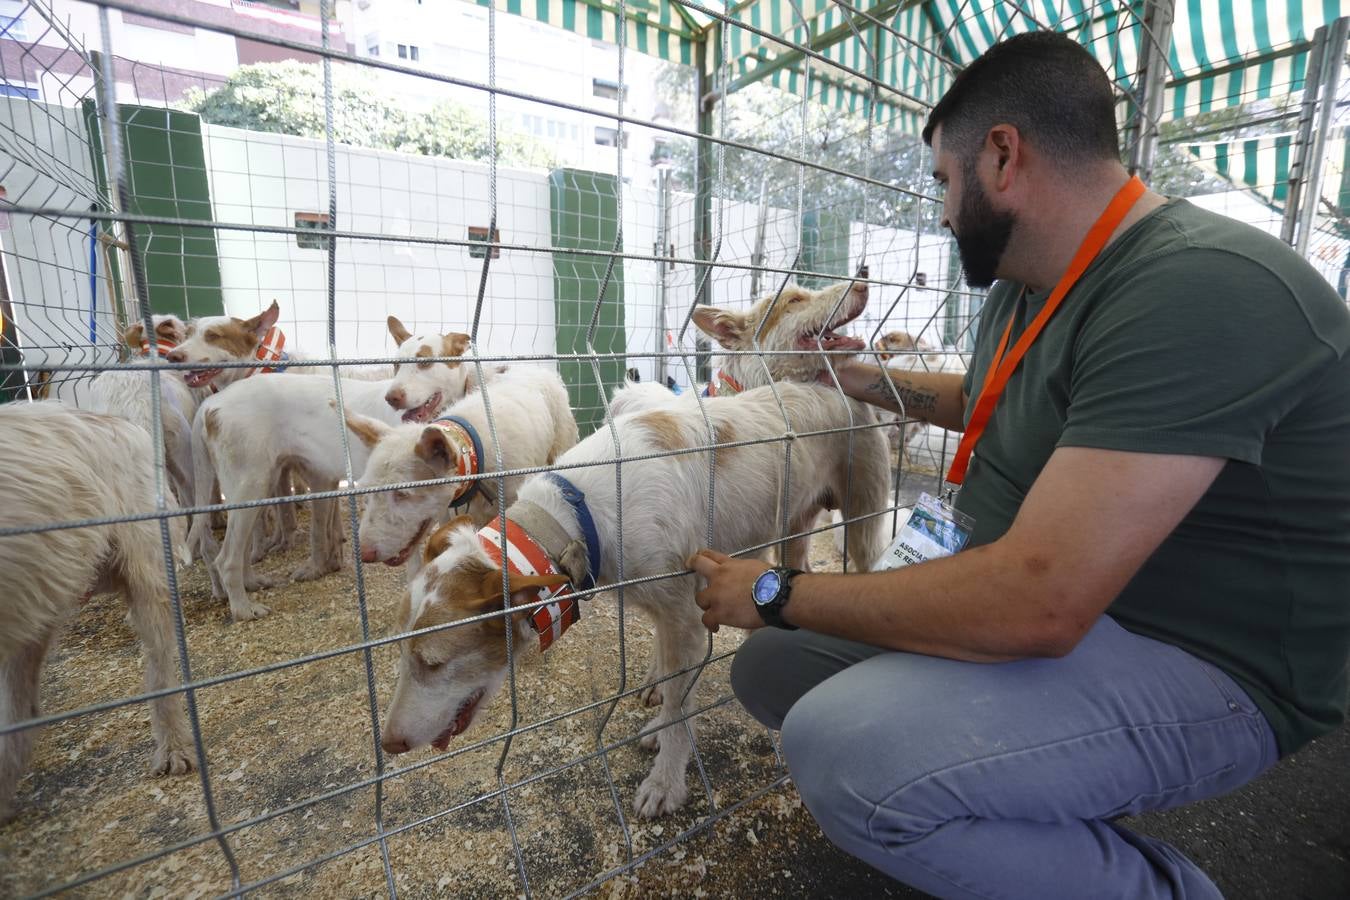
[192,320,467,621]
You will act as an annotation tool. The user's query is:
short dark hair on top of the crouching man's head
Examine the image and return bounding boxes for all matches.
[923,31,1121,162]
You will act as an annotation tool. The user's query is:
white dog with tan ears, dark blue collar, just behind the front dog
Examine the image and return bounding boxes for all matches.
[347,366,576,579]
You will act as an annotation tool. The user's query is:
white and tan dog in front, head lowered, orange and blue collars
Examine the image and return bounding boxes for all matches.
[383,383,879,816]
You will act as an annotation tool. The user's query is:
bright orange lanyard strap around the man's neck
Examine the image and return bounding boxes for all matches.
[946,177,1148,486]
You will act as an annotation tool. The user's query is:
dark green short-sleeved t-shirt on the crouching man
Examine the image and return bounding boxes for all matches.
[957,201,1350,753]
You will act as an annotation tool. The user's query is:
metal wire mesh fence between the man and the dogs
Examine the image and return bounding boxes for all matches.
[0,0,1346,896]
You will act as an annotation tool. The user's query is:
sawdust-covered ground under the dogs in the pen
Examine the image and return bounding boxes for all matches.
[0,477,934,897]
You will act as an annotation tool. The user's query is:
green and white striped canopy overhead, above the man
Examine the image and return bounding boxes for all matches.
[478,0,1350,131]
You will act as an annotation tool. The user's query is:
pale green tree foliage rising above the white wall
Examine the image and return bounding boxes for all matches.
[184,61,555,167]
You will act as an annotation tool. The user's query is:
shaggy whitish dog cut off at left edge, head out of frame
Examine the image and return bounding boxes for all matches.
[0,402,196,820]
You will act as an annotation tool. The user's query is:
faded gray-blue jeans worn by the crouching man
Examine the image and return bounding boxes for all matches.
[732,617,1277,900]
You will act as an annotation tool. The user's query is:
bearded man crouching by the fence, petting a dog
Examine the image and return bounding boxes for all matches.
[691,32,1350,899]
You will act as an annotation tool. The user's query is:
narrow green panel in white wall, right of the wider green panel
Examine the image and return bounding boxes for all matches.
[548,169,626,437]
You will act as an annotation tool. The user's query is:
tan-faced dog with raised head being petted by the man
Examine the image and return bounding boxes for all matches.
[685,272,890,571]
